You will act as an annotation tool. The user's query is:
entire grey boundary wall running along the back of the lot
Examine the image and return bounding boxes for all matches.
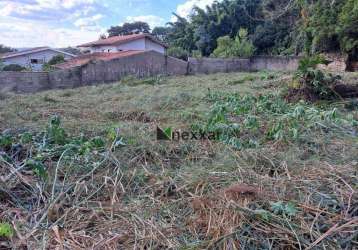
[0,51,299,93]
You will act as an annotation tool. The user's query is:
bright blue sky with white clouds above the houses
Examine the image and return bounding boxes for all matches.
[0,0,218,48]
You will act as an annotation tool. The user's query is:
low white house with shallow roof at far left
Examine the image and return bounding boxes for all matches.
[0,47,76,71]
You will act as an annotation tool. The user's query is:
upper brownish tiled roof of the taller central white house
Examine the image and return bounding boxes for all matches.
[77,34,168,48]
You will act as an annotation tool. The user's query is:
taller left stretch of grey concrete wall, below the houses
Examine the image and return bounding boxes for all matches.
[0,51,188,93]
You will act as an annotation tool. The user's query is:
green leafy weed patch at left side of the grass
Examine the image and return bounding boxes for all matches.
[0,116,125,182]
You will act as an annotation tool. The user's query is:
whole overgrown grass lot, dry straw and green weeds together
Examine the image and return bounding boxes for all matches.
[0,72,358,249]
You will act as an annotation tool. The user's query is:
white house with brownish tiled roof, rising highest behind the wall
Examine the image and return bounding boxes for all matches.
[77,34,167,54]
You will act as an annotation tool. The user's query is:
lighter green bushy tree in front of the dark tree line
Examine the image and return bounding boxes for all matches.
[212,29,255,58]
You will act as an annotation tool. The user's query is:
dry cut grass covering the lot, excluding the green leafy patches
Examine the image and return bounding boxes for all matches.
[0,73,358,249]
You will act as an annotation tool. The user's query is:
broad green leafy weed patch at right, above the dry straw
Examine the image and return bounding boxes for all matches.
[197,93,358,149]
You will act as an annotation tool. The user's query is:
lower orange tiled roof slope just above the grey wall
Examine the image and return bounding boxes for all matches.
[55,50,145,69]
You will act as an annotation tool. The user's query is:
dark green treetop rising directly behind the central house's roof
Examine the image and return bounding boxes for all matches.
[108,22,150,37]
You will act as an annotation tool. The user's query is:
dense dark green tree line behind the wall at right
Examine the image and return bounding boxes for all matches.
[148,0,358,57]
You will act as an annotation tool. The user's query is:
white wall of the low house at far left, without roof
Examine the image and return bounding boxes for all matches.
[2,50,72,71]
